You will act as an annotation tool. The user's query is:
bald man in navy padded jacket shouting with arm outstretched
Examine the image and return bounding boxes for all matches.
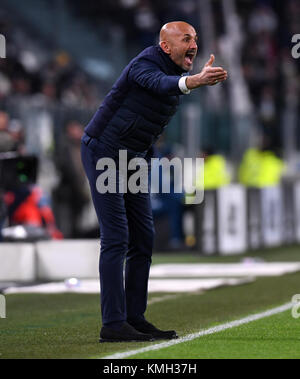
[82,22,227,342]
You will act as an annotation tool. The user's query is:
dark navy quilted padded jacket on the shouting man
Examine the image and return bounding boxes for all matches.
[85,46,185,153]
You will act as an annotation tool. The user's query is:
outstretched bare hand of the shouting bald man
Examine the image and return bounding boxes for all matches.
[186,55,228,89]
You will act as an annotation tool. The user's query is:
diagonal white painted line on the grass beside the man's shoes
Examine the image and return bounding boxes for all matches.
[101,303,293,359]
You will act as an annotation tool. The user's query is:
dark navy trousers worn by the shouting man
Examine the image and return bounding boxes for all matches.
[81,134,154,325]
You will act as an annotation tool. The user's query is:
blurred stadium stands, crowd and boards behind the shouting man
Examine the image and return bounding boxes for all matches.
[0,0,300,280]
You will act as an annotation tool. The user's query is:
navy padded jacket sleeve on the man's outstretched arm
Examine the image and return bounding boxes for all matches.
[128,57,183,96]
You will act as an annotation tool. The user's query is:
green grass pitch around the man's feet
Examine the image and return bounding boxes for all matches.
[0,246,300,359]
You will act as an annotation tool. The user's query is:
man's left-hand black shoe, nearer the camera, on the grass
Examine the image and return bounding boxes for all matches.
[99,322,154,342]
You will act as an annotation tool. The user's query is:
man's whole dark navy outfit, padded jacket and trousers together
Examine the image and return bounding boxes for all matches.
[81,46,183,325]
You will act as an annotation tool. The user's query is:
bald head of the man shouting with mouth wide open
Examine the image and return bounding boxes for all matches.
[159,21,198,71]
